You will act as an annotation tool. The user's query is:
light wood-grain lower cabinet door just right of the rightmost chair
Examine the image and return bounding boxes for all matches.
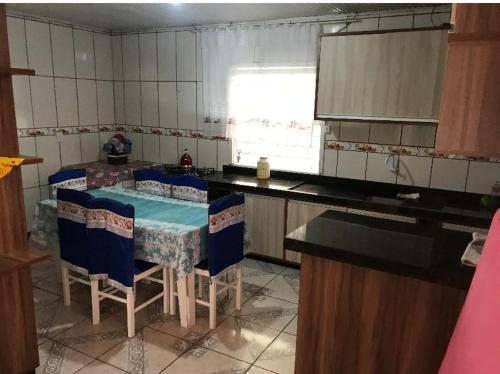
[245,194,285,259]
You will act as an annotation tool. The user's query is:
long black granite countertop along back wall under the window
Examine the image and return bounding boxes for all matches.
[204,165,500,228]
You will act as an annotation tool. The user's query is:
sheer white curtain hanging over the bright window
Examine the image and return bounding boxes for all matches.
[201,23,320,172]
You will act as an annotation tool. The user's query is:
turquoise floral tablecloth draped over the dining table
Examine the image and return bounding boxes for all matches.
[30,187,208,279]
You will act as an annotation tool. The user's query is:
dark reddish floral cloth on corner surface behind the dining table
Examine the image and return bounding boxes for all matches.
[64,161,157,188]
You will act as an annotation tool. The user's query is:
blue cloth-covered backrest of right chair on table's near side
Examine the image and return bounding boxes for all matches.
[87,198,135,290]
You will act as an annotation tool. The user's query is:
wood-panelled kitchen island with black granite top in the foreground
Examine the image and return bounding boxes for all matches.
[285,211,473,374]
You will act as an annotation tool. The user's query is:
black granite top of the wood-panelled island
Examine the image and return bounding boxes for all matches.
[284,211,473,289]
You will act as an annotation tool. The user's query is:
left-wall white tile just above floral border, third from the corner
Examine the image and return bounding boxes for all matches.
[55,78,78,127]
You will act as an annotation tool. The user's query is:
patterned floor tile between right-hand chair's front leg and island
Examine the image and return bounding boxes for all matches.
[233,296,297,331]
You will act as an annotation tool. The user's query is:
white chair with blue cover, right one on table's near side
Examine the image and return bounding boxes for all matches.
[87,198,169,337]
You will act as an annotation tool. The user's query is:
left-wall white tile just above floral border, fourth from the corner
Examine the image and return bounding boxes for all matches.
[30,77,57,127]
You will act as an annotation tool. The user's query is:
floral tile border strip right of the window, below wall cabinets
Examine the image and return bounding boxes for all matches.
[325,141,500,162]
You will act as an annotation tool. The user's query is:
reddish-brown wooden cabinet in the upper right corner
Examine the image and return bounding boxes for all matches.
[436,4,500,157]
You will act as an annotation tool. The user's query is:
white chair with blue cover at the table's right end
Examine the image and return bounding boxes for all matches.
[195,194,245,329]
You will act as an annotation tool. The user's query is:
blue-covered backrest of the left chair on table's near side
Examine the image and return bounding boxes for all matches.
[57,188,92,274]
